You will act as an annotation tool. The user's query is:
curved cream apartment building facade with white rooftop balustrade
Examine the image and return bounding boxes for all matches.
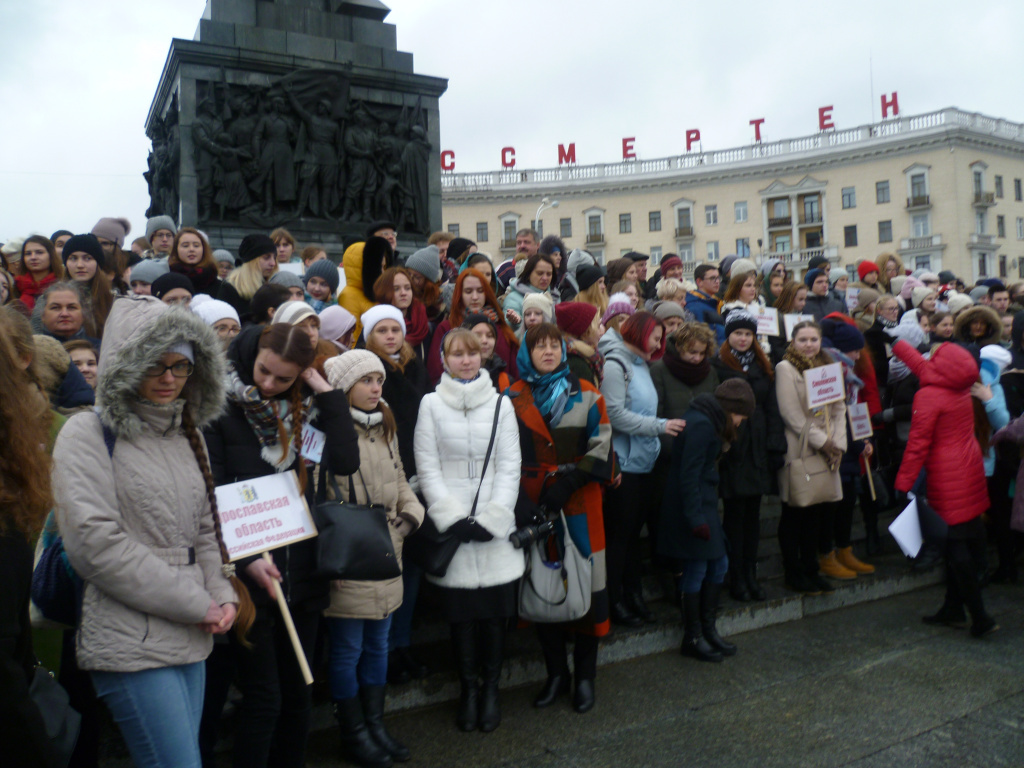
[441,108,1024,283]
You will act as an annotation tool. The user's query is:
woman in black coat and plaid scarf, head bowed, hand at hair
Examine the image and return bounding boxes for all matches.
[200,323,359,766]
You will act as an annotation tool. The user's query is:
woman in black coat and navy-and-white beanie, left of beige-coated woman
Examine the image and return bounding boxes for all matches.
[712,309,785,602]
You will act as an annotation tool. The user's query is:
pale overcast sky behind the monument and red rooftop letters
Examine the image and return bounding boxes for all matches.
[0,0,1024,240]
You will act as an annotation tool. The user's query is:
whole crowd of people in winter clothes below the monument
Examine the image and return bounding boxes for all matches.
[0,216,1024,768]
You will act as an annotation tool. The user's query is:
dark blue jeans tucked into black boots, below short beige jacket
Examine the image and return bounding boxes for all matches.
[327,616,391,700]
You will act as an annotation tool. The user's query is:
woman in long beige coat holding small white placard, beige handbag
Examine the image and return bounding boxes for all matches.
[775,321,846,595]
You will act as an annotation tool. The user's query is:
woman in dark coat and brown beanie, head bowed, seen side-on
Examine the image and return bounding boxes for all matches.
[657,379,755,662]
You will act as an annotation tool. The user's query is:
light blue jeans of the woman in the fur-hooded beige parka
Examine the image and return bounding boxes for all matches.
[91,662,206,768]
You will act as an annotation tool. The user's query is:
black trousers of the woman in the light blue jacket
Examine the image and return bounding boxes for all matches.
[604,472,658,605]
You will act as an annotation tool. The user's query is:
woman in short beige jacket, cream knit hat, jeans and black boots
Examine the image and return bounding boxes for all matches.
[324,354,423,766]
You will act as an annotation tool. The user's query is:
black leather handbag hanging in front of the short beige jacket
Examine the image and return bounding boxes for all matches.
[313,461,401,582]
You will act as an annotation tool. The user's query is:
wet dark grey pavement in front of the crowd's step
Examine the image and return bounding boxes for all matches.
[303,586,1024,768]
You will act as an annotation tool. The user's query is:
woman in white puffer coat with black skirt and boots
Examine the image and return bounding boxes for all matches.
[415,329,525,732]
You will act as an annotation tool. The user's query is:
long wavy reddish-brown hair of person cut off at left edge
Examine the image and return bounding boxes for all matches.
[0,307,53,538]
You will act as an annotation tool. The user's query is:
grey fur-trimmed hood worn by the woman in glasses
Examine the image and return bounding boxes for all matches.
[96,296,227,440]
